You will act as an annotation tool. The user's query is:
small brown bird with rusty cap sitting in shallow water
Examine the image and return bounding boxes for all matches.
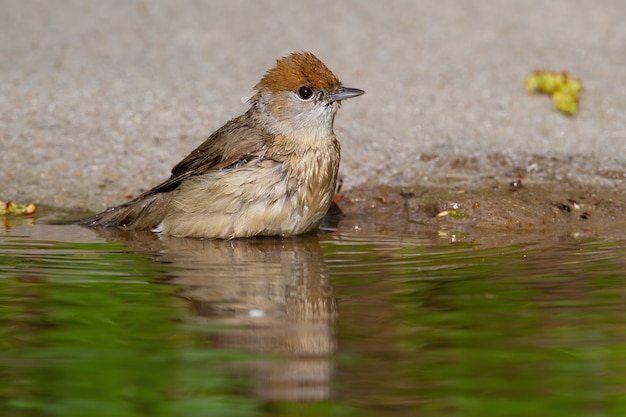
[82,52,364,239]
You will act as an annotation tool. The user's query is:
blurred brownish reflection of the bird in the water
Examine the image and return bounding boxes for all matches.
[93,226,337,402]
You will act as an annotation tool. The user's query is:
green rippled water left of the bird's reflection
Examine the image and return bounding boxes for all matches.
[0,238,258,416]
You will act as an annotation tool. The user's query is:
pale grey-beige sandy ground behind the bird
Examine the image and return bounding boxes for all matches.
[0,0,626,226]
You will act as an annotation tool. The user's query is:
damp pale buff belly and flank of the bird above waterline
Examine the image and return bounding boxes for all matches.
[157,150,339,239]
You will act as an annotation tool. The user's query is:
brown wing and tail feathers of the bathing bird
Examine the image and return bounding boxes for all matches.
[81,113,273,229]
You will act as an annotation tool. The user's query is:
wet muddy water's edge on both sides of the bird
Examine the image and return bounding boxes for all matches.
[7,173,626,247]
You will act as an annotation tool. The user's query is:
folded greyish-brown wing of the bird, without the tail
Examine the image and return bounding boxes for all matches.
[148,114,272,194]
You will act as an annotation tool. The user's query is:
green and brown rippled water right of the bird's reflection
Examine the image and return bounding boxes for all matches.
[328,239,626,416]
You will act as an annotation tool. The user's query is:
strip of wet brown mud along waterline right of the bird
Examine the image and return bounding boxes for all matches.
[339,179,626,235]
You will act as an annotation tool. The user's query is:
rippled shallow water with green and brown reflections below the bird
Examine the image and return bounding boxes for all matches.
[0,216,626,416]
